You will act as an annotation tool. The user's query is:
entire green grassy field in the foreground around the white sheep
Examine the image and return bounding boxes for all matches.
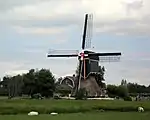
[0,99,150,120]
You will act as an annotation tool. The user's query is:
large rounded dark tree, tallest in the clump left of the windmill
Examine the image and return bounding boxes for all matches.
[23,69,55,97]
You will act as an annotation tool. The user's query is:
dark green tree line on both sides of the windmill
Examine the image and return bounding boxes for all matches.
[0,69,150,98]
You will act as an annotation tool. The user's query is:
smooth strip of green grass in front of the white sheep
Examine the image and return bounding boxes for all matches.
[0,112,150,120]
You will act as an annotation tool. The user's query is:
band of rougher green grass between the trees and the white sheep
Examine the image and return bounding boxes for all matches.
[0,99,150,114]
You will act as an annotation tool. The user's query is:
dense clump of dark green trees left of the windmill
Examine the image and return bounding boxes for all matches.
[1,69,55,98]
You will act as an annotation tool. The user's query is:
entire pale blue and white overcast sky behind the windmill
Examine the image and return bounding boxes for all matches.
[0,0,150,85]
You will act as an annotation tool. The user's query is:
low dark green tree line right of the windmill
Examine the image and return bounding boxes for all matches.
[107,80,150,99]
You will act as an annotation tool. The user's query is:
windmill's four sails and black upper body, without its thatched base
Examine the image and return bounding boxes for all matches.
[47,14,121,96]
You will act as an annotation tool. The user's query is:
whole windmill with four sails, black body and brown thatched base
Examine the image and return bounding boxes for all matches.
[47,14,121,96]
